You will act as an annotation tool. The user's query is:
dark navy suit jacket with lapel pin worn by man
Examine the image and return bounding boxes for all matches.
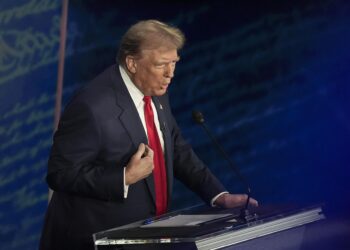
[40,65,224,250]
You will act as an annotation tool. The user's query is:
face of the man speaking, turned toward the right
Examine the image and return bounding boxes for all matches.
[126,47,179,96]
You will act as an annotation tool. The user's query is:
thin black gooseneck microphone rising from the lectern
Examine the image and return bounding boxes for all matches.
[192,110,256,222]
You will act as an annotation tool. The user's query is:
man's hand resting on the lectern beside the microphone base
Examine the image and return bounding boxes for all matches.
[214,193,258,208]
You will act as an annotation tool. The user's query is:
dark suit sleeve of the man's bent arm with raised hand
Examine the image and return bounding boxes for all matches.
[46,98,123,200]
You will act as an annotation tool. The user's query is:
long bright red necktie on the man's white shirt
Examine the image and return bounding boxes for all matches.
[143,96,167,216]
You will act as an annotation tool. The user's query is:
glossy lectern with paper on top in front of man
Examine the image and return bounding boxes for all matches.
[93,205,325,250]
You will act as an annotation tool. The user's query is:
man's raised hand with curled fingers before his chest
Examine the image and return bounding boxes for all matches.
[125,143,154,185]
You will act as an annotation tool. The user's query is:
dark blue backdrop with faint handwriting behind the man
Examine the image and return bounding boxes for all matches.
[0,0,350,249]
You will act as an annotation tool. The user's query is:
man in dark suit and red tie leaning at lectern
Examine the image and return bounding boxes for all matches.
[40,20,257,250]
